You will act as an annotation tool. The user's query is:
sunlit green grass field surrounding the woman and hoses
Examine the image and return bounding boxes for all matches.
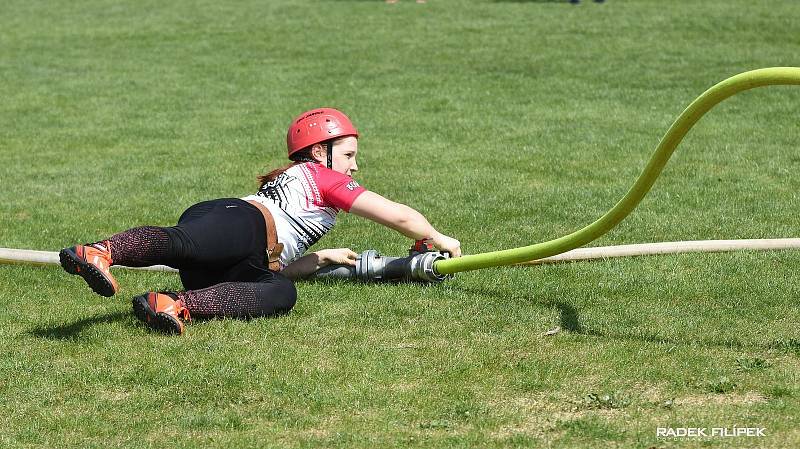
[0,0,800,448]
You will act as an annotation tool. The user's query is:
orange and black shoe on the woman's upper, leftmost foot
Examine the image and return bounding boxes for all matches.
[58,241,118,296]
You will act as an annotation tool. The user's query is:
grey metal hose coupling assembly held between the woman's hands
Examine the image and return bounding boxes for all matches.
[311,242,452,283]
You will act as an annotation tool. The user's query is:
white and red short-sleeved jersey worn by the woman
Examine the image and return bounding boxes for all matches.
[242,162,366,269]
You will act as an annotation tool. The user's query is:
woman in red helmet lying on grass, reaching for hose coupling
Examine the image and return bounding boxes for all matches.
[59,108,461,334]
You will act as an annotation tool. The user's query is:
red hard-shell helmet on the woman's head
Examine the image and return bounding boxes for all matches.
[286,108,358,158]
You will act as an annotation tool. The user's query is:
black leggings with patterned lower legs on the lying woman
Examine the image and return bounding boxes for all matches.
[100,198,297,317]
